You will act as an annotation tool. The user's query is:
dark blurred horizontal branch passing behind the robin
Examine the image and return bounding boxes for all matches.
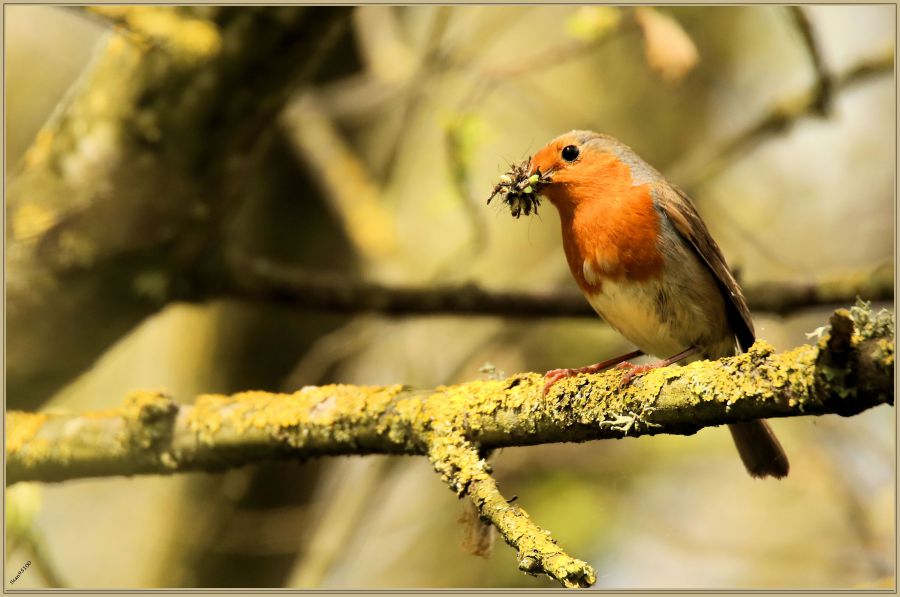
[207,255,894,318]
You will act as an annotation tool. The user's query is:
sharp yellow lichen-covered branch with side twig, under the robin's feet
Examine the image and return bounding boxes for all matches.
[6,305,894,586]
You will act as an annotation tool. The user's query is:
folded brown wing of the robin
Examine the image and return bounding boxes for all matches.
[654,183,754,350]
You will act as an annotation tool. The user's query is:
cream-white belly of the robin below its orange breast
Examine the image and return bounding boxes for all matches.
[587,279,688,359]
